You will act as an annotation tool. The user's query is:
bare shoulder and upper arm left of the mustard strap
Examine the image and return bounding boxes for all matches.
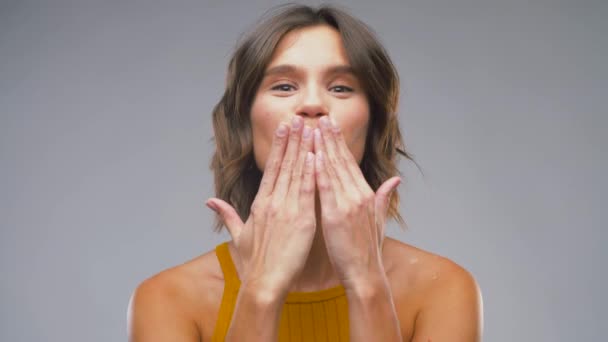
[127,250,224,342]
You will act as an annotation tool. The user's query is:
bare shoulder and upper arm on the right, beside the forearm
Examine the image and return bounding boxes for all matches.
[383,239,483,341]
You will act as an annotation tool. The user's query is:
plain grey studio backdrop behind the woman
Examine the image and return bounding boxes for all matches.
[0,0,608,341]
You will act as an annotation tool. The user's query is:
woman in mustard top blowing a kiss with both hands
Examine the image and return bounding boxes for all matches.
[129,5,482,342]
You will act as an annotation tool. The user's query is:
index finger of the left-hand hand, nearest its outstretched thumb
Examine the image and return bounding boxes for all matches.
[257,122,289,197]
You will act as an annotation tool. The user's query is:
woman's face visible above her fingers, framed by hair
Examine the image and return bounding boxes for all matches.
[251,25,370,170]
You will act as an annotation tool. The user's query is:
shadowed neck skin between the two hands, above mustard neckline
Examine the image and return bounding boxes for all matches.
[290,193,340,292]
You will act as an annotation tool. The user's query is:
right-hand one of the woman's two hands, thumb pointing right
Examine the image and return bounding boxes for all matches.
[314,116,401,290]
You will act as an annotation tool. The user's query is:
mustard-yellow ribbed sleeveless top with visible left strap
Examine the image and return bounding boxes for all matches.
[212,242,349,342]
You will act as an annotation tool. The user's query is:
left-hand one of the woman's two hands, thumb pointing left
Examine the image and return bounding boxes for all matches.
[207,116,316,297]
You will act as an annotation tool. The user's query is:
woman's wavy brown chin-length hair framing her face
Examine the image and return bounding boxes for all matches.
[211,4,417,231]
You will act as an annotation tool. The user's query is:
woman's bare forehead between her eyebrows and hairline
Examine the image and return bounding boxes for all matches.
[268,25,350,68]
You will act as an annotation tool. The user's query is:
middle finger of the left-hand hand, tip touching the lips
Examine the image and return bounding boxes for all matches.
[272,115,304,201]
